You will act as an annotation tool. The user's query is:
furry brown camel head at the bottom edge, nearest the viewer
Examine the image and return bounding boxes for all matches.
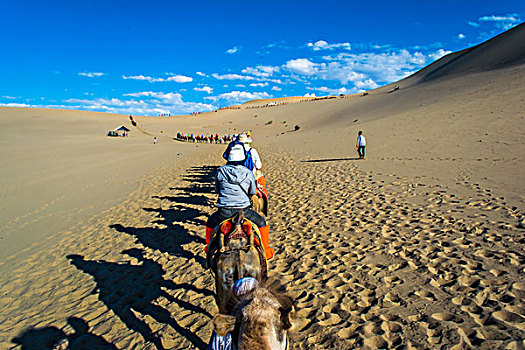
[213,283,295,350]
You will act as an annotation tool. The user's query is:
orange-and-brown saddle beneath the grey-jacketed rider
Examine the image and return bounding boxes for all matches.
[206,211,268,278]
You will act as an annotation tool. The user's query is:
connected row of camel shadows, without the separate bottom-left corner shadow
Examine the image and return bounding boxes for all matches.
[68,167,217,349]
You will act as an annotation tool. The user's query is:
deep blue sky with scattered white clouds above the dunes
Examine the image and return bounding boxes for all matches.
[0,0,525,116]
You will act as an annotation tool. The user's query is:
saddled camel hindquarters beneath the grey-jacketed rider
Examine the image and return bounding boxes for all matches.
[207,212,268,314]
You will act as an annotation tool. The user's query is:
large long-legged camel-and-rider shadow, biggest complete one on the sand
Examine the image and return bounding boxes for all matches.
[67,248,211,349]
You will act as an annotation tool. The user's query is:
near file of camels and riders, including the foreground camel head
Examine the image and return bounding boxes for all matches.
[206,133,294,350]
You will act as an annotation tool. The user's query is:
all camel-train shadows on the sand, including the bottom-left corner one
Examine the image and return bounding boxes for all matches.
[12,166,218,350]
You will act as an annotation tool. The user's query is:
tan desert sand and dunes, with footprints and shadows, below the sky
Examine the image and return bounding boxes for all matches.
[0,25,525,349]
